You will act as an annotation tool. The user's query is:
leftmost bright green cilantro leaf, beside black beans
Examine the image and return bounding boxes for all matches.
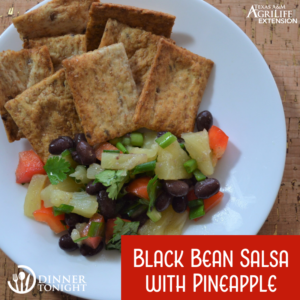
[44,156,71,185]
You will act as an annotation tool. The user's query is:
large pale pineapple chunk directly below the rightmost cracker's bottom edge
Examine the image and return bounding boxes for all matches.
[155,141,192,180]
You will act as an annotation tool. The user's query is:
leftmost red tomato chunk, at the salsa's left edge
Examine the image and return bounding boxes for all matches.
[16,150,46,183]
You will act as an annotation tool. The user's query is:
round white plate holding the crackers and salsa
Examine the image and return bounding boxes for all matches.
[0,0,286,300]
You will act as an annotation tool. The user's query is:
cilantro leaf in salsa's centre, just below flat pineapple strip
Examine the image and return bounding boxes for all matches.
[95,170,129,200]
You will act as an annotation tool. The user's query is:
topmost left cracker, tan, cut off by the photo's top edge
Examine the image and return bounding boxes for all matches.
[13,0,99,40]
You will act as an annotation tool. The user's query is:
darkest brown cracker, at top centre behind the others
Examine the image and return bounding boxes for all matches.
[86,3,176,51]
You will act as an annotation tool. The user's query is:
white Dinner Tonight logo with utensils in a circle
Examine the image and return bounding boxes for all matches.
[7,265,87,294]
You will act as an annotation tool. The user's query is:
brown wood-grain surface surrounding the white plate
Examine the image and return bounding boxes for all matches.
[0,0,300,300]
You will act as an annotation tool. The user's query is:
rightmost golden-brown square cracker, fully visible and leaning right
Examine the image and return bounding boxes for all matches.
[134,39,213,136]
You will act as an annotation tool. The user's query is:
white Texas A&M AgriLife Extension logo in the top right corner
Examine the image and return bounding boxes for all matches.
[247,4,298,24]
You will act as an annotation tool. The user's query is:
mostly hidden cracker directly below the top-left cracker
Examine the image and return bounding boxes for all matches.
[23,34,86,71]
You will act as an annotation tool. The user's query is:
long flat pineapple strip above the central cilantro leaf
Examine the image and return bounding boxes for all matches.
[101,153,148,170]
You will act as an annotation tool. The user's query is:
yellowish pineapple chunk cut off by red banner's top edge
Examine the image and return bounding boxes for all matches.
[138,206,189,235]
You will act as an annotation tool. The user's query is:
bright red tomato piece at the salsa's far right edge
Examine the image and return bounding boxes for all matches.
[208,126,229,159]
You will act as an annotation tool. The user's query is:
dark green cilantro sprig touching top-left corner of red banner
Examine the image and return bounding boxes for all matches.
[106,218,140,251]
